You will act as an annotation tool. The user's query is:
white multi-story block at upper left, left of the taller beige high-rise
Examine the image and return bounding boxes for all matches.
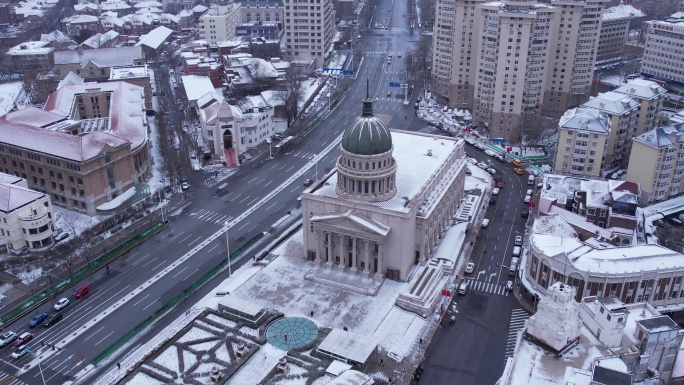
[198,3,241,45]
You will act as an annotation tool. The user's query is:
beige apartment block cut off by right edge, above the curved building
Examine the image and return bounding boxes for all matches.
[627,124,684,204]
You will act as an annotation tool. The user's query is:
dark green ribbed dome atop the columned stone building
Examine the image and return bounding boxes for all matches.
[342,115,392,155]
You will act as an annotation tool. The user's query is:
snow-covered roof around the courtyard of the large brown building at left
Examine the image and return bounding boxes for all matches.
[0,82,147,162]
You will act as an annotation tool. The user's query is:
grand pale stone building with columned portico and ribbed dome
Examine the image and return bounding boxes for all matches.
[302,84,466,294]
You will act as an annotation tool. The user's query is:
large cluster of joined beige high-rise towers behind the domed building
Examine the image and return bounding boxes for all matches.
[432,0,607,142]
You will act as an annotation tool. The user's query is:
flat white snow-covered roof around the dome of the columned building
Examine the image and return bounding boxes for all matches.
[312,131,462,213]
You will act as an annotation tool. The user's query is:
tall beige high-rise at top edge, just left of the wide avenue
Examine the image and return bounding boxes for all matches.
[284,0,335,67]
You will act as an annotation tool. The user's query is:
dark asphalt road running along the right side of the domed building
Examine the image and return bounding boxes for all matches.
[420,145,533,385]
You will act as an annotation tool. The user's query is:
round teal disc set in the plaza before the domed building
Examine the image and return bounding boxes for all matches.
[266,317,318,350]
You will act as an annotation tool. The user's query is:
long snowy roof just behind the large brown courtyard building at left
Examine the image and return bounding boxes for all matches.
[55,47,143,68]
